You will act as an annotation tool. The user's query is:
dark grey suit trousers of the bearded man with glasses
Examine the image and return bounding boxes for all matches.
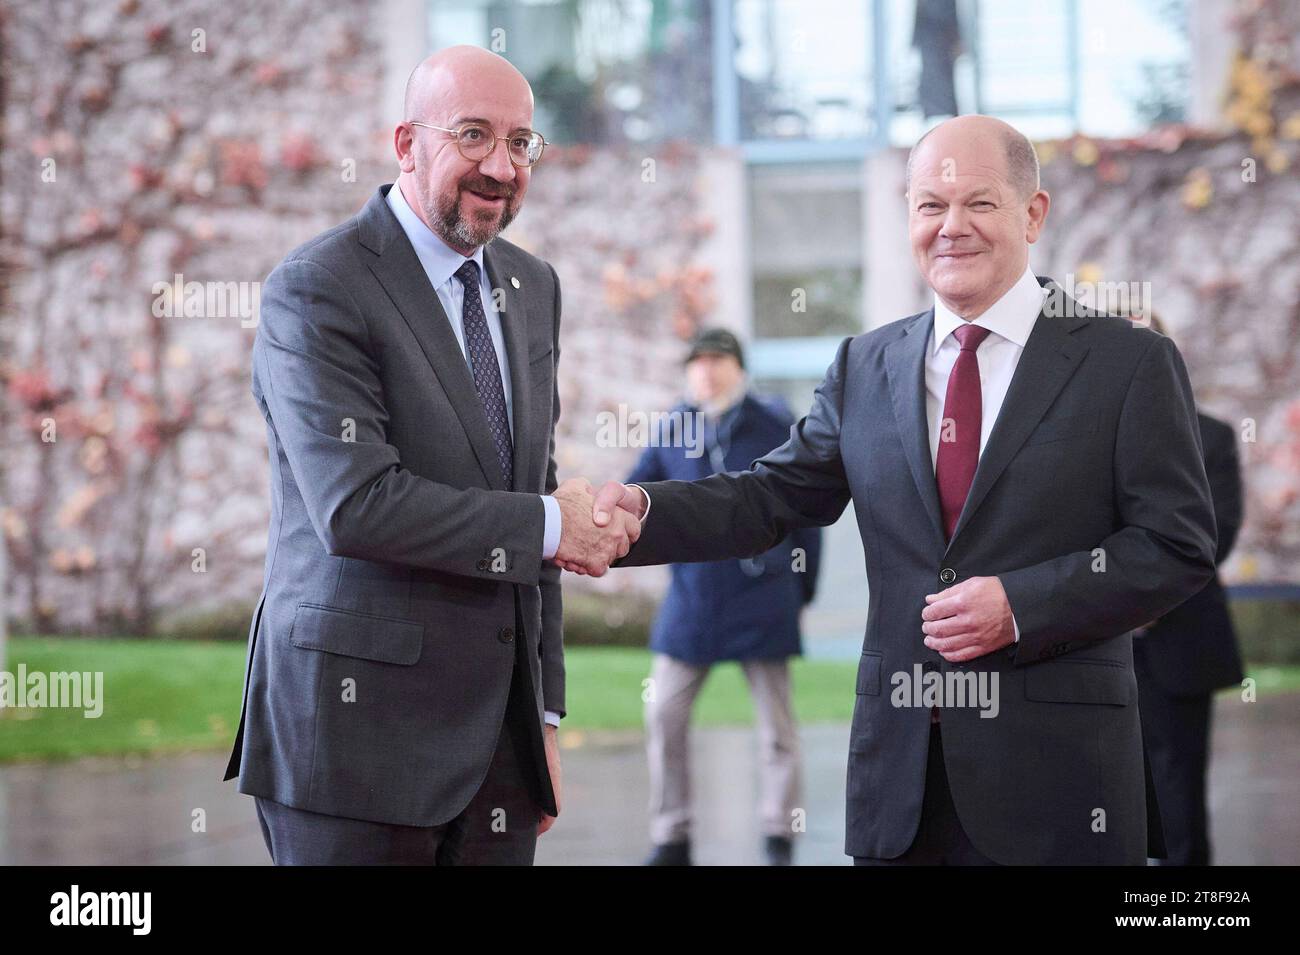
[256,641,542,865]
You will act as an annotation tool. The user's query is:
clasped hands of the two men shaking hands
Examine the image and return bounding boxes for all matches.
[551,478,649,577]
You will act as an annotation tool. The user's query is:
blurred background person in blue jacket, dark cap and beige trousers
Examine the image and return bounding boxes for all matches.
[627,329,820,865]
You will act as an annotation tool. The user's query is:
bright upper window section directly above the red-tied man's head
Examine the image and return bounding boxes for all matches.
[887,0,1191,146]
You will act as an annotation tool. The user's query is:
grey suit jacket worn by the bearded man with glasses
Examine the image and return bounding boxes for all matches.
[225,186,564,826]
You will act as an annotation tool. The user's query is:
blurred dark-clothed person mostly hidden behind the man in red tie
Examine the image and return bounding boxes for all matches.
[1134,314,1243,865]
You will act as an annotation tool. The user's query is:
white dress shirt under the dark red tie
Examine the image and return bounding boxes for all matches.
[926,266,1048,642]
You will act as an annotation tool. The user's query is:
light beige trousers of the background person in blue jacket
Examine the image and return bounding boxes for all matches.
[645,654,801,846]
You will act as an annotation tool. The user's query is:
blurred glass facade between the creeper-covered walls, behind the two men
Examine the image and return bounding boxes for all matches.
[428,0,1191,381]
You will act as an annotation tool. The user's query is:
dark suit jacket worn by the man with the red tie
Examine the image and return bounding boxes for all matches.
[620,279,1214,865]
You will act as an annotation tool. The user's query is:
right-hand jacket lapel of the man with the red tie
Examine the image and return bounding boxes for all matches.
[949,286,1088,548]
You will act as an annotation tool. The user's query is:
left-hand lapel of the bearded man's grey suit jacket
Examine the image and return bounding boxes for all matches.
[360,186,519,491]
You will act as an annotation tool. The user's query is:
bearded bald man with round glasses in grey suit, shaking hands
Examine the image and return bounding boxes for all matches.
[225,47,640,864]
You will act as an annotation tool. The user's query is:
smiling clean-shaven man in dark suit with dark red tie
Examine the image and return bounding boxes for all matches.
[569,116,1216,865]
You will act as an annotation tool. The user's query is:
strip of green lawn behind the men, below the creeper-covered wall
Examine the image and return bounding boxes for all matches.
[0,637,1300,761]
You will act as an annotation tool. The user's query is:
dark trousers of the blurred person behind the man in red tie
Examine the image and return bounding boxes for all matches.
[1134,654,1214,865]
